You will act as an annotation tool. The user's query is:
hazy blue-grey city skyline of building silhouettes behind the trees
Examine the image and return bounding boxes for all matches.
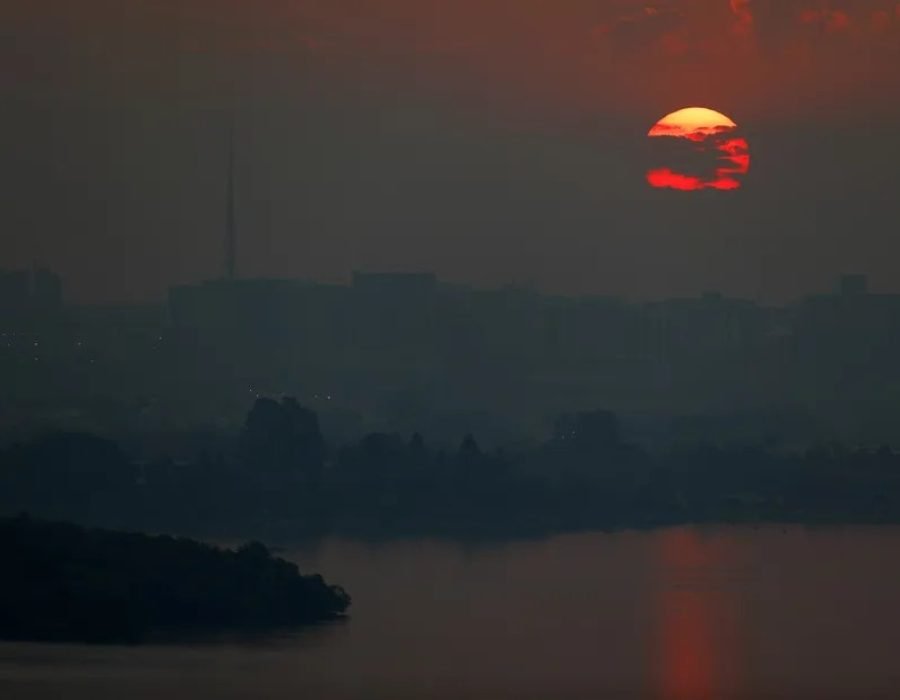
[0,271,900,448]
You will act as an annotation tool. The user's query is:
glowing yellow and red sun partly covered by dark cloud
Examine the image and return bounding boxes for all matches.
[647,107,750,192]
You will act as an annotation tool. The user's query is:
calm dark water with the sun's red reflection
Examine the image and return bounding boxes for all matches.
[0,528,900,700]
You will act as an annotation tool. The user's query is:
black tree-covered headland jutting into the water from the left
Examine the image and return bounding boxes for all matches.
[0,517,350,643]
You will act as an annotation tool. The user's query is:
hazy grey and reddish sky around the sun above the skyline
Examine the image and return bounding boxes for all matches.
[0,0,900,300]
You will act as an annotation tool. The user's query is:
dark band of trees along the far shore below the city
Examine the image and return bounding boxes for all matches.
[0,398,900,542]
